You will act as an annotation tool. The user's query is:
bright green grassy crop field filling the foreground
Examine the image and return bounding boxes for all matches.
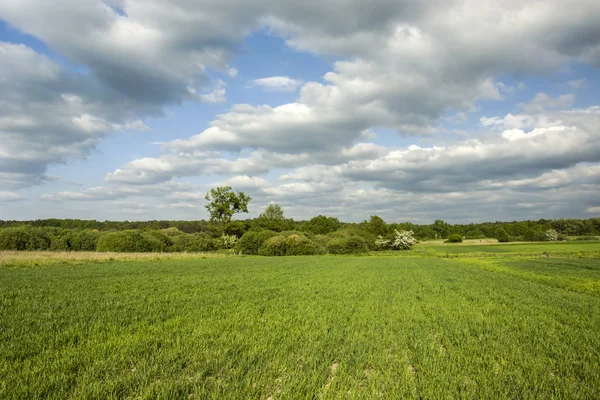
[0,243,600,400]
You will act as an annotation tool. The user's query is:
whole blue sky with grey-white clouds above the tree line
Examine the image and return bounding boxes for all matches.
[0,0,600,223]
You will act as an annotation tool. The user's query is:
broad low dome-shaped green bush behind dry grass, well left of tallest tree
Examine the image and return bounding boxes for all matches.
[96,230,168,253]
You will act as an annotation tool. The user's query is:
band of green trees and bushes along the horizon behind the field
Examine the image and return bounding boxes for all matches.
[0,186,600,255]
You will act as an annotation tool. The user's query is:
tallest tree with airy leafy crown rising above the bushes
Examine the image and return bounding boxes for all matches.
[204,186,252,234]
